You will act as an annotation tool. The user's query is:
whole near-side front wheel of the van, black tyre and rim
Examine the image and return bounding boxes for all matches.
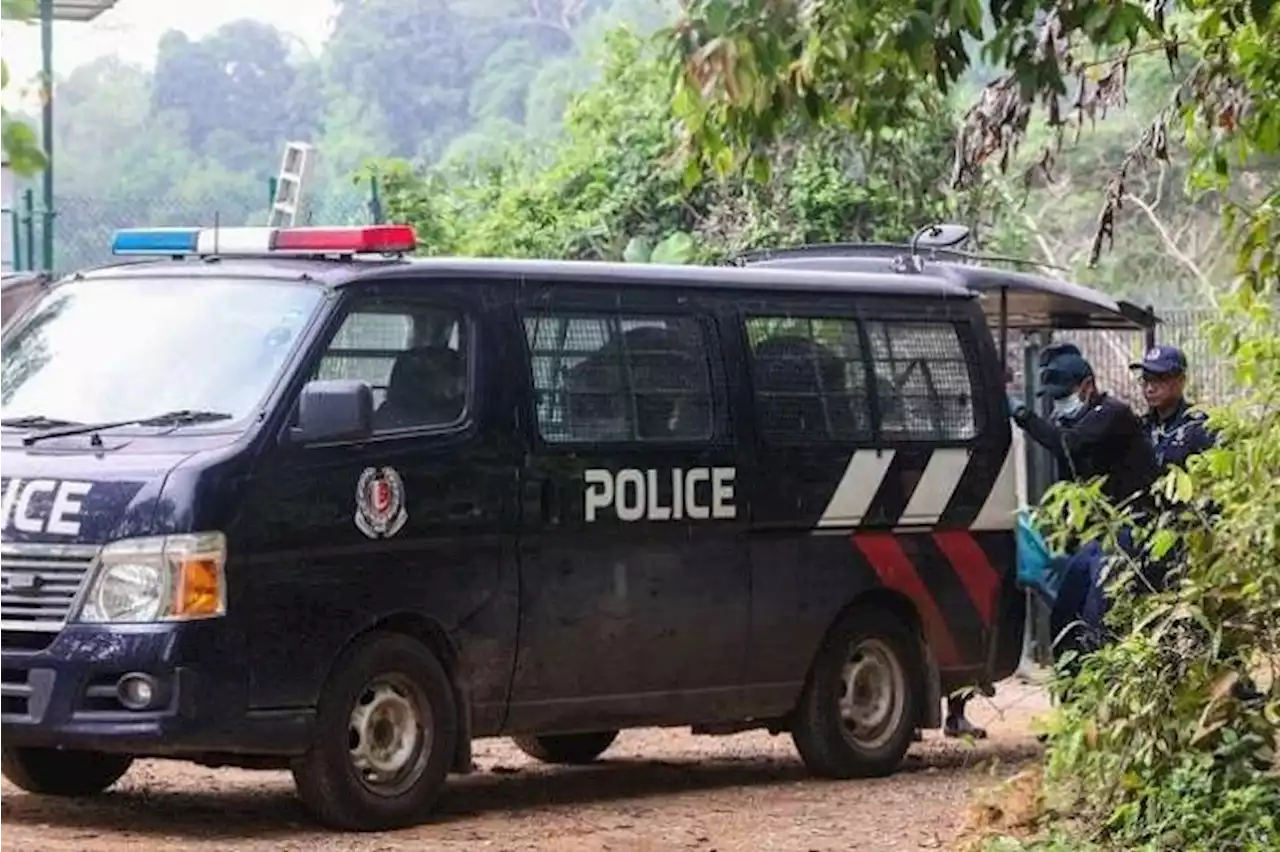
[292,633,458,832]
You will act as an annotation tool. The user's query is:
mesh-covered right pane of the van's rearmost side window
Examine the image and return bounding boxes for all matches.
[867,322,978,441]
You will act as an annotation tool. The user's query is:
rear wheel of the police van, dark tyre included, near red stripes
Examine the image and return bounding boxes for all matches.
[791,610,924,779]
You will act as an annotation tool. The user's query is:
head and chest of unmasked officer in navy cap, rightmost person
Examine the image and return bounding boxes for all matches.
[1129,345,1213,469]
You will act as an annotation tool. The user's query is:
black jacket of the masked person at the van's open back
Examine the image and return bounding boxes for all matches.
[1015,394,1160,505]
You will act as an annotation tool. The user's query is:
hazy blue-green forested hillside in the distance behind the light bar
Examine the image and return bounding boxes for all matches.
[32,0,676,270]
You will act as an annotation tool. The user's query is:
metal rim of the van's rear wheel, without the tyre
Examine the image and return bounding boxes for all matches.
[840,638,906,750]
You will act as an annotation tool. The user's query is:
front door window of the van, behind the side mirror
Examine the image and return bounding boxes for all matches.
[314,299,470,431]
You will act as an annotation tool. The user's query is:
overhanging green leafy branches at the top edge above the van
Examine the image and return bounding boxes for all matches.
[664,0,1153,182]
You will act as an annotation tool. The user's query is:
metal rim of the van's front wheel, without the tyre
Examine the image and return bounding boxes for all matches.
[347,674,431,797]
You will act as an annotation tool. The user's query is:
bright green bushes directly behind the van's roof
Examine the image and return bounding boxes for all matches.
[381,31,954,262]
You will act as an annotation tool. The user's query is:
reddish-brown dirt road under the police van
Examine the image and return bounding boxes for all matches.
[0,681,1047,852]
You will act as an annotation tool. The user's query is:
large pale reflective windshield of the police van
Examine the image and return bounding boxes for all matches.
[0,278,324,426]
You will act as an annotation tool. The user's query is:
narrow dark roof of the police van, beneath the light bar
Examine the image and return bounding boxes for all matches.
[77,256,975,299]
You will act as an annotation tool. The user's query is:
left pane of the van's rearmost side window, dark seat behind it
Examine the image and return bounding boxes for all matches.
[746,316,872,444]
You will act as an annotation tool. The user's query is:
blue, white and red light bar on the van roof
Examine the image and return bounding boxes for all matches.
[111,225,417,257]
